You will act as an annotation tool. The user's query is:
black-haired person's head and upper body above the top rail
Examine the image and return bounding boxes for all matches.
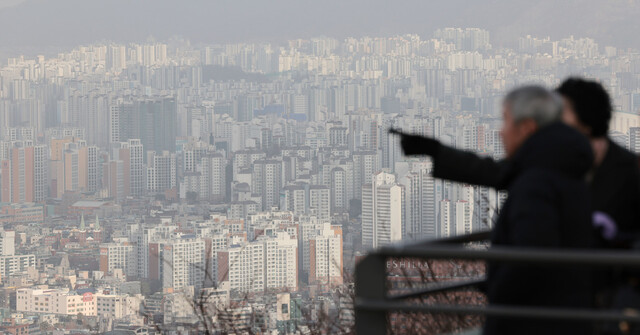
[556,78,640,248]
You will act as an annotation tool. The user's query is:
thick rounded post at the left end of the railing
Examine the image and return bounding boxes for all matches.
[354,254,389,335]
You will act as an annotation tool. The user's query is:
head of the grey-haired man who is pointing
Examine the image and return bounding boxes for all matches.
[501,86,562,157]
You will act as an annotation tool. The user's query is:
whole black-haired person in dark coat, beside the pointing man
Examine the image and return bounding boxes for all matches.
[557,78,640,334]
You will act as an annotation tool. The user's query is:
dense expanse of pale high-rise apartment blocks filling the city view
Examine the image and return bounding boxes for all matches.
[0,27,640,334]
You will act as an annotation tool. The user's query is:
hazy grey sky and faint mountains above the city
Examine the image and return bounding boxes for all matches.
[0,0,640,50]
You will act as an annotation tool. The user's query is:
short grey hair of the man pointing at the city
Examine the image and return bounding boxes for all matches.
[504,86,562,127]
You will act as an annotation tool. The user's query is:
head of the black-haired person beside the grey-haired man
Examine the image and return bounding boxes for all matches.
[556,78,612,138]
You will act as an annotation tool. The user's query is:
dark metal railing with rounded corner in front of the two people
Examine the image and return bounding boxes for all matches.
[354,232,640,335]
